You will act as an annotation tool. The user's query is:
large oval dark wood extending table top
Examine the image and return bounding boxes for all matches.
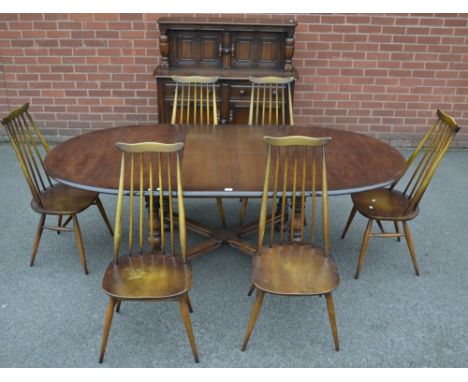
[44,124,406,197]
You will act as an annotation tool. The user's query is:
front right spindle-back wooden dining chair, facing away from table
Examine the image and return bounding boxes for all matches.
[241,136,339,351]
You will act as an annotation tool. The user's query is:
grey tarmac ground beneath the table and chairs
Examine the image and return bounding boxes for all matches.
[0,144,468,367]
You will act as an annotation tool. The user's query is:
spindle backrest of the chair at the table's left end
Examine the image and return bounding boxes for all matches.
[2,103,52,206]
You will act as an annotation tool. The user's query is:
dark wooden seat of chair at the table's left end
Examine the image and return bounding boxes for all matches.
[31,184,99,215]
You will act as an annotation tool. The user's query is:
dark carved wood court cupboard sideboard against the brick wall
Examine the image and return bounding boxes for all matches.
[153,15,298,124]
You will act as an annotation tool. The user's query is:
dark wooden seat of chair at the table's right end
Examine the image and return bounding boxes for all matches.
[351,188,419,221]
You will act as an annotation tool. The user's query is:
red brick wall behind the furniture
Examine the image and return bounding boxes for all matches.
[0,14,468,147]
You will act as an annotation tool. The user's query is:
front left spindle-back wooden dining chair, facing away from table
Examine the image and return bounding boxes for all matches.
[99,142,199,363]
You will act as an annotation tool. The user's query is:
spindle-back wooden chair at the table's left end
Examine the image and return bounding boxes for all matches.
[2,103,113,274]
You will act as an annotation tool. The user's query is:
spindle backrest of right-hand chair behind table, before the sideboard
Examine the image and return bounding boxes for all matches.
[249,77,294,126]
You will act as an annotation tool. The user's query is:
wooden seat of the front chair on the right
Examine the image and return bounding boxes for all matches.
[252,244,340,296]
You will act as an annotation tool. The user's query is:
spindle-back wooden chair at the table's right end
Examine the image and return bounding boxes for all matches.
[341,110,460,279]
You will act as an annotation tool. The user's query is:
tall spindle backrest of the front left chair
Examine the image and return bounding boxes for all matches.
[114,142,187,263]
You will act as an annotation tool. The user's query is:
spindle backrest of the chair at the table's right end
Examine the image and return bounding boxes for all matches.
[391,110,460,212]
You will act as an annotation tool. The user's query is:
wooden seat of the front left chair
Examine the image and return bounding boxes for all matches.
[102,254,192,300]
